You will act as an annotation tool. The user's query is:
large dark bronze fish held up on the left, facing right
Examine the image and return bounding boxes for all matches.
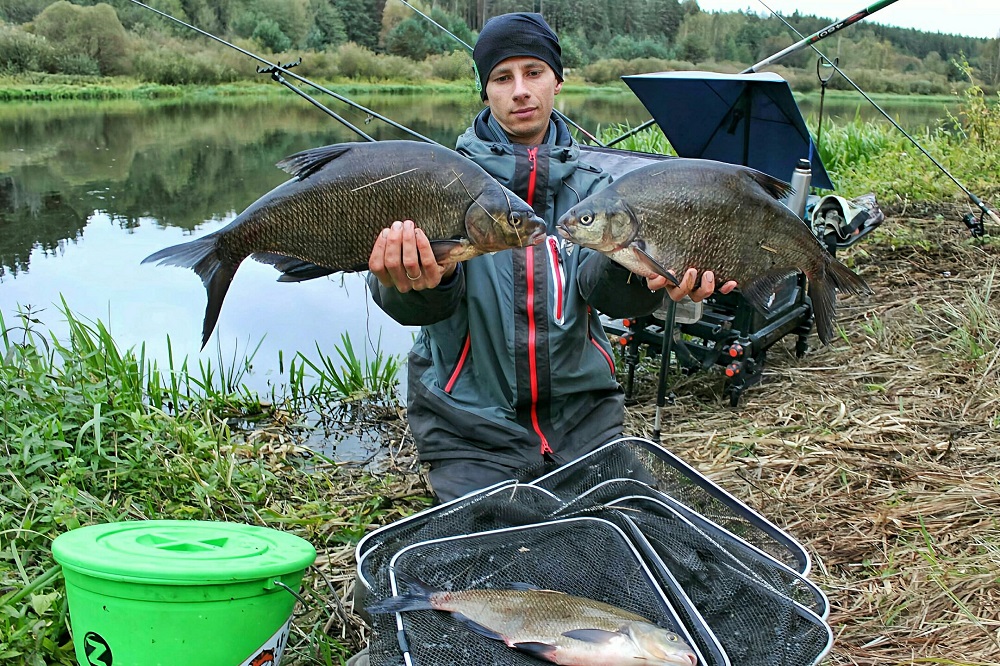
[142,141,545,346]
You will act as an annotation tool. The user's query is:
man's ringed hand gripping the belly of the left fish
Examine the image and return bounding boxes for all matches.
[368,220,457,294]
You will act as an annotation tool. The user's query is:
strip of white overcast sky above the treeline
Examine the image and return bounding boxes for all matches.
[697,0,1000,38]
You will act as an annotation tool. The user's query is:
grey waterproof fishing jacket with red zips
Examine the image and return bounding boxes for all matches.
[368,109,662,469]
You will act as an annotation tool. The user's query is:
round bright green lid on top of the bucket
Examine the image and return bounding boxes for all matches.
[52,520,316,585]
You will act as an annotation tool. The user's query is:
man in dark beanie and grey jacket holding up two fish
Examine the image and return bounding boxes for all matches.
[368,13,735,501]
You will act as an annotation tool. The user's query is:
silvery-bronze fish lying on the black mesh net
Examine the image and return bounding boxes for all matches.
[368,580,698,666]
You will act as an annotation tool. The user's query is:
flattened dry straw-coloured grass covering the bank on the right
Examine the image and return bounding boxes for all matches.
[303,214,1000,666]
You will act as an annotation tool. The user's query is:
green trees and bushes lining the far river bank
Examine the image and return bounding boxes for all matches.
[0,0,1000,94]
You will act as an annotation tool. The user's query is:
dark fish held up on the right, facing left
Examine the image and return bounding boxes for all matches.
[557,158,871,343]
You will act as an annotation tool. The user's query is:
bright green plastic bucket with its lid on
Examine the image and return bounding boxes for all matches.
[52,520,316,666]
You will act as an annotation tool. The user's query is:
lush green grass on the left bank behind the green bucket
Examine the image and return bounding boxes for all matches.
[0,302,410,666]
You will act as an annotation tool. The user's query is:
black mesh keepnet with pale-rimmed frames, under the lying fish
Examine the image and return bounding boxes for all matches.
[355,438,832,666]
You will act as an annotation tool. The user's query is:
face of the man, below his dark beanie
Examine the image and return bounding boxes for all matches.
[486,56,562,146]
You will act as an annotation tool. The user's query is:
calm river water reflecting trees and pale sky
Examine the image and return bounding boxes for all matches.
[0,92,944,394]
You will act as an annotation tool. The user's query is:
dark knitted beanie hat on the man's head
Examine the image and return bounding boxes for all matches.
[472,12,563,99]
